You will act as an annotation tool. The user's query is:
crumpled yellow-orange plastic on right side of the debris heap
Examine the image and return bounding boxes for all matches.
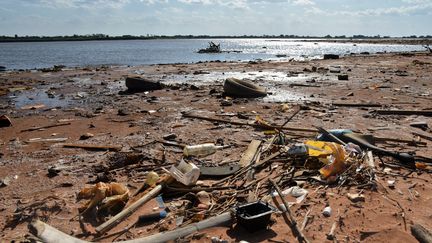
[305,140,346,179]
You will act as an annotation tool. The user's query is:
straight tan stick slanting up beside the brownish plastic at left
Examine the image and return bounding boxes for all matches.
[96,185,163,234]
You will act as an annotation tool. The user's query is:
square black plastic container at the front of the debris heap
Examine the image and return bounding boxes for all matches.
[236,201,276,232]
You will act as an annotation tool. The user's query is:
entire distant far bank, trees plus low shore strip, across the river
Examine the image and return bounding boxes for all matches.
[0,34,432,45]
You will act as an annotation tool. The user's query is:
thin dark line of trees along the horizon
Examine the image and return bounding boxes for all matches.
[0,34,432,42]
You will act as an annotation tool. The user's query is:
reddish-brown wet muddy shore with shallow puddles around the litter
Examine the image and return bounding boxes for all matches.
[0,50,432,242]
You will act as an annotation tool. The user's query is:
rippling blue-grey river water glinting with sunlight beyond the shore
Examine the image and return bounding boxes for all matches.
[0,39,424,69]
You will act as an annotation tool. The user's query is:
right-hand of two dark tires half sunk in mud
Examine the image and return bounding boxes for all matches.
[224,78,267,98]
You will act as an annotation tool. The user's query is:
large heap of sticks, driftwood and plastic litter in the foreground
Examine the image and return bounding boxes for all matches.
[26,107,430,242]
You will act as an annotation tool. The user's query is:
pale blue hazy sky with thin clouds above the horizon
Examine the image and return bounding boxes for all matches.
[0,0,432,36]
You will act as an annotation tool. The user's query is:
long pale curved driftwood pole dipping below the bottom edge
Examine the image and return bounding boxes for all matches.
[29,211,232,243]
